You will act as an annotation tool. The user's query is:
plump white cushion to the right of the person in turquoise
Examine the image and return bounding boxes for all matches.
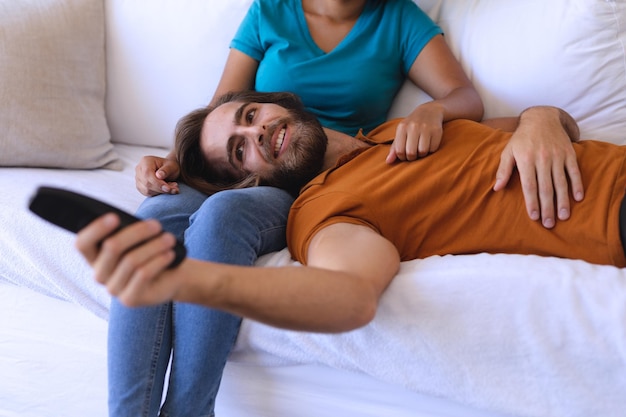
[439,0,626,144]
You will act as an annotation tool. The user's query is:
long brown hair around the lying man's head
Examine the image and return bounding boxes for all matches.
[174,91,305,195]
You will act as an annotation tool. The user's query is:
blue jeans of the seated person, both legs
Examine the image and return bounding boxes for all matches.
[108,184,293,417]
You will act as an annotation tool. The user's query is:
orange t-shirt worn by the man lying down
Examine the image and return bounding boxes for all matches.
[287,120,626,267]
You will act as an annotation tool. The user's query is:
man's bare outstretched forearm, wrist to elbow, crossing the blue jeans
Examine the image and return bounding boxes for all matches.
[171,259,378,332]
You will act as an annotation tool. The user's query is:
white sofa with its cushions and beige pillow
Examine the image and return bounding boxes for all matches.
[0,0,626,417]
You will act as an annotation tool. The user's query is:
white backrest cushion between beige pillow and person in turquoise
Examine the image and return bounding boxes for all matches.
[106,0,251,148]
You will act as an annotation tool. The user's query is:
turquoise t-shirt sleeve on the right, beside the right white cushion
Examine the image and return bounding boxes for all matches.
[398,1,443,74]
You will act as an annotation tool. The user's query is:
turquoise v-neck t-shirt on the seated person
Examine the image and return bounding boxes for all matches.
[231,0,442,135]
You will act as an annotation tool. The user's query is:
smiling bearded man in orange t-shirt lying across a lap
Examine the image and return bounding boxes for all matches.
[76,92,626,332]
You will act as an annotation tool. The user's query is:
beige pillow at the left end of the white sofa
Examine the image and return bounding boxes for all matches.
[0,0,121,169]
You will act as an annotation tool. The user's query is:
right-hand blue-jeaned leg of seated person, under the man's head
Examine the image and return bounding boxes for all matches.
[156,187,293,416]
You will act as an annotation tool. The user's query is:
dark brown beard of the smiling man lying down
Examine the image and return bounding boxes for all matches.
[260,106,328,195]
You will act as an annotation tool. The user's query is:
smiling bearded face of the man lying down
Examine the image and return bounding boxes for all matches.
[200,102,328,192]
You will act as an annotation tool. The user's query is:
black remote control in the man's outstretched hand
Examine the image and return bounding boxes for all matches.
[28,187,187,268]
